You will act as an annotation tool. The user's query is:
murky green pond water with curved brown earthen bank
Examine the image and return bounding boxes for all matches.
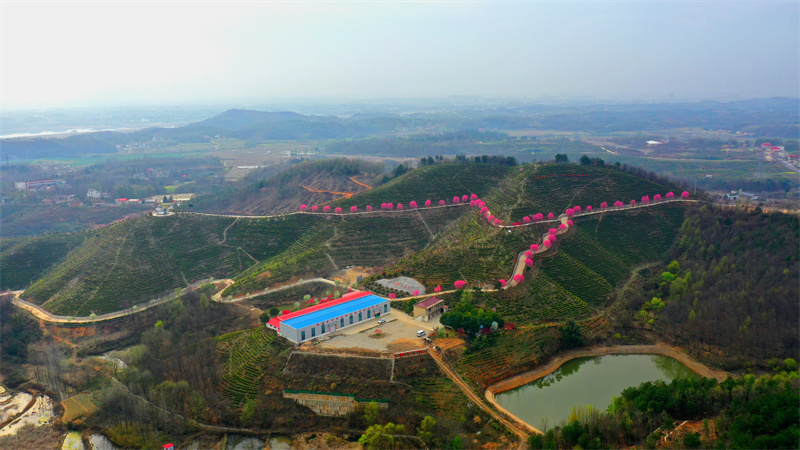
[496,355,697,430]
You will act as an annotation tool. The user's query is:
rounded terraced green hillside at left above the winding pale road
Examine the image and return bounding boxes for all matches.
[23,215,322,315]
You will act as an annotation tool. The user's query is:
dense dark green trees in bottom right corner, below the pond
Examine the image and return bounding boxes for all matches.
[528,372,800,449]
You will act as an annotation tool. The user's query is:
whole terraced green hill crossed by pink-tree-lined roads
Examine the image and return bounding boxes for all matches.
[20,162,682,321]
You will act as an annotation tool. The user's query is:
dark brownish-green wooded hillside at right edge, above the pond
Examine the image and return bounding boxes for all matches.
[629,206,800,368]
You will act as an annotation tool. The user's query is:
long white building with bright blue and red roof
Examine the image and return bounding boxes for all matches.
[267,292,390,344]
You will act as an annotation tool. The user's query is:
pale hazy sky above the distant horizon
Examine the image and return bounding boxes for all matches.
[0,0,800,110]
